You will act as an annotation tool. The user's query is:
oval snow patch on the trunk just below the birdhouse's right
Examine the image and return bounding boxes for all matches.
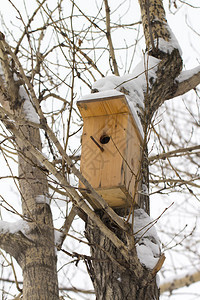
[132,208,161,269]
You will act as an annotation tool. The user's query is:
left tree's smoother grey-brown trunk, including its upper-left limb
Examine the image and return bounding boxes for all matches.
[0,37,59,300]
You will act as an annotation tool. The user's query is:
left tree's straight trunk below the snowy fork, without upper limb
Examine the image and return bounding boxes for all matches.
[17,126,59,300]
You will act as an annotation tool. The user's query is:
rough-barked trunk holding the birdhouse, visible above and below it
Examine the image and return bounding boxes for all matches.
[86,0,182,300]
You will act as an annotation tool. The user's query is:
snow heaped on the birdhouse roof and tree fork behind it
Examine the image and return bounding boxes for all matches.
[80,55,160,137]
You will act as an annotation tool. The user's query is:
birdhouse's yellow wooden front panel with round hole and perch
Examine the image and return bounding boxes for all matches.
[81,114,128,189]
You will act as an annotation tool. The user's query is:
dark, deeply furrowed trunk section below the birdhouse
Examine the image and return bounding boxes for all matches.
[86,212,159,300]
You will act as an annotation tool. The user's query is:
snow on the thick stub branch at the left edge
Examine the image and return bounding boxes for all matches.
[0,219,29,234]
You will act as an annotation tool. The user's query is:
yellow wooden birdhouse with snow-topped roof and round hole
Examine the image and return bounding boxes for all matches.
[77,91,143,209]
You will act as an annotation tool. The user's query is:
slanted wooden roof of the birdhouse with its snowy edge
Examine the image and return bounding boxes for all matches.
[77,90,144,141]
